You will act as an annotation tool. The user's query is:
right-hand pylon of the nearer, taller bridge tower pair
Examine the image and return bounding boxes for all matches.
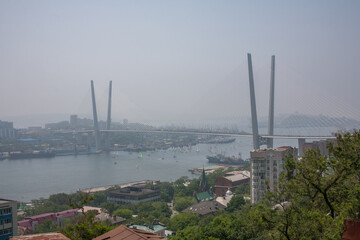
[267,55,275,148]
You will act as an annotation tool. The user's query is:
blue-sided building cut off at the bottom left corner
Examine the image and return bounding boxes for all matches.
[0,199,17,240]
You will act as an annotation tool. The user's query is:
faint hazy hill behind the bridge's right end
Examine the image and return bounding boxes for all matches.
[278,114,360,129]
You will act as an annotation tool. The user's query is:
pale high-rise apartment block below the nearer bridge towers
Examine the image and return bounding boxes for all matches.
[250,146,298,203]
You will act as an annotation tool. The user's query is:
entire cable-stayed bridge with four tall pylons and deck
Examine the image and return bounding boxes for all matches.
[87,54,335,155]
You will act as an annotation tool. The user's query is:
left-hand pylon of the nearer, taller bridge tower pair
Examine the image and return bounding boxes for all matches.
[248,53,260,149]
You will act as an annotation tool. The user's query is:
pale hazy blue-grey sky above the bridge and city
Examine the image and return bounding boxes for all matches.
[0,0,360,126]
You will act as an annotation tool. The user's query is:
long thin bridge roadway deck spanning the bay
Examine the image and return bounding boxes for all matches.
[63,129,336,139]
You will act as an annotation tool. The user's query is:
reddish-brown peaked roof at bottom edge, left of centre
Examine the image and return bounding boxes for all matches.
[93,225,164,240]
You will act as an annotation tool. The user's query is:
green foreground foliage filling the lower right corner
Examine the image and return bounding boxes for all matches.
[171,132,360,240]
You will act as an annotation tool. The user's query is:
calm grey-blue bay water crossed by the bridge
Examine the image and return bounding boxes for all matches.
[0,129,329,201]
